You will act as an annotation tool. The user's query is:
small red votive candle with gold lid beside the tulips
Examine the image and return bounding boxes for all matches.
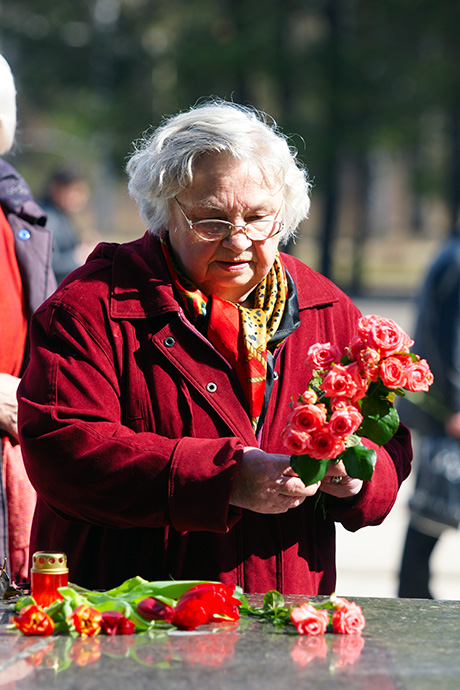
[30,551,69,607]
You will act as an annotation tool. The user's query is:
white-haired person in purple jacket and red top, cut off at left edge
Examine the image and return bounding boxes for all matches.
[0,55,56,583]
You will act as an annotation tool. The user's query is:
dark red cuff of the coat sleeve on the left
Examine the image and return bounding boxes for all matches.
[168,437,243,533]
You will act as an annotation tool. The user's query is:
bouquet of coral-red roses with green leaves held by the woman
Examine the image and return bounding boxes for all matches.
[283,315,433,485]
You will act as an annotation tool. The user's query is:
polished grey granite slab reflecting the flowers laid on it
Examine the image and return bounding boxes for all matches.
[0,596,460,690]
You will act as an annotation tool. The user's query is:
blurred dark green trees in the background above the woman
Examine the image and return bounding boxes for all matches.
[0,0,460,292]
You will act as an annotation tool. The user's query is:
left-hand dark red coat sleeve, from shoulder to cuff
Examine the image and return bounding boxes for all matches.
[18,293,242,532]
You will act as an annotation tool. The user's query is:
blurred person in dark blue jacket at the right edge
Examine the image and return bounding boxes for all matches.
[398,235,460,599]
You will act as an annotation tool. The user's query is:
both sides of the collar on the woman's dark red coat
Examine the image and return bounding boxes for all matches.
[89,232,337,319]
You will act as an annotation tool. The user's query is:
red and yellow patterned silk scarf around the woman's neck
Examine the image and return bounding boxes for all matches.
[162,240,287,431]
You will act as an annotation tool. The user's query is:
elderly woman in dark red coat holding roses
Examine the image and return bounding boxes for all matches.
[19,102,411,594]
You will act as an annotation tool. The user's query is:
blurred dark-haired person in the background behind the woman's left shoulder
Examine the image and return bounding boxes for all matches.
[40,167,92,283]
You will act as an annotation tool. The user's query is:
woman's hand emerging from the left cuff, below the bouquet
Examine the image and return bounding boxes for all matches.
[230,447,319,513]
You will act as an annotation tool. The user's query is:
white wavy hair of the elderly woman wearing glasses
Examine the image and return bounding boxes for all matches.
[126,100,311,242]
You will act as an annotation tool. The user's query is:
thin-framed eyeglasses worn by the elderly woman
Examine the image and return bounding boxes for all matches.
[174,197,284,242]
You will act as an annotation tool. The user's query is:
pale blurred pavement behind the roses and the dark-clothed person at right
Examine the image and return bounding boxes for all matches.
[336,298,460,600]
